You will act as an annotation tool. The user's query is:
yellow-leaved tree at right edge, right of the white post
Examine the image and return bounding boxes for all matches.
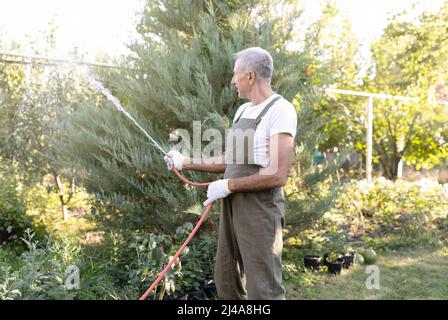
[361,2,448,179]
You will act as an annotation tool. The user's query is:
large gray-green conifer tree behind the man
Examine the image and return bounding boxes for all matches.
[57,0,344,231]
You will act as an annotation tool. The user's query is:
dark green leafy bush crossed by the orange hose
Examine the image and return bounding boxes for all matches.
[90,223,216,299]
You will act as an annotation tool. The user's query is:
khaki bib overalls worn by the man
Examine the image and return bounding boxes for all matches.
[215,97,285,300]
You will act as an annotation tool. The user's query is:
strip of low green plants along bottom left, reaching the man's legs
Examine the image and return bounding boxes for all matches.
[0,224,216,300]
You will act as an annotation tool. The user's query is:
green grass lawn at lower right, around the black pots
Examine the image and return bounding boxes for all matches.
[286,247,448,300]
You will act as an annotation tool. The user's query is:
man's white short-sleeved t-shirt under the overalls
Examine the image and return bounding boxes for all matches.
[233,94,297,168]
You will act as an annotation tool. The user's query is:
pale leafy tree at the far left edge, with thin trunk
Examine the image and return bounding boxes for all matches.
[0,28,91,219]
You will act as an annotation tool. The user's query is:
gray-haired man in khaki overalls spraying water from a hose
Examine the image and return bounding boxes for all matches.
[165,48,297,300]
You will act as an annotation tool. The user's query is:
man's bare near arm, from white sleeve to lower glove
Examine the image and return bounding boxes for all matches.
[228,133,294,192]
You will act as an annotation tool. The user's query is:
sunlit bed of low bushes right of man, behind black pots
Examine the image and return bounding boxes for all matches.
[285,178,448,261]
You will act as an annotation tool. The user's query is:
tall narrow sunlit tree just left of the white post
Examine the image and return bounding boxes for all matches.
[305,1,364,151]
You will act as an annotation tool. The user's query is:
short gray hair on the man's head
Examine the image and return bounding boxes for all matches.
[235,47,274,82]
